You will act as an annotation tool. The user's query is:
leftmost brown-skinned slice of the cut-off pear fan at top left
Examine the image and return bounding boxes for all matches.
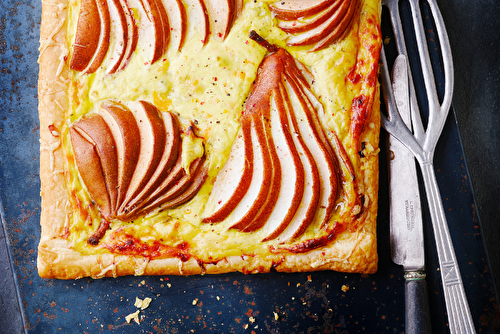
[70,0,111,73]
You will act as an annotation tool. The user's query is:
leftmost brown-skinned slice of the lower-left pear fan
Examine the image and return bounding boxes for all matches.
[70,127,112,217]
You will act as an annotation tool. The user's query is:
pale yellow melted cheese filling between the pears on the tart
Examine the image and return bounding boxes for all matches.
[62,0,380,261]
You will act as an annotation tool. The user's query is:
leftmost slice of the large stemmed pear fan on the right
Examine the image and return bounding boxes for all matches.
[203,126,253,223]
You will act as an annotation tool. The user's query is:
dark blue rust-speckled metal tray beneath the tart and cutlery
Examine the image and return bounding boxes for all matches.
[0,0,500,333]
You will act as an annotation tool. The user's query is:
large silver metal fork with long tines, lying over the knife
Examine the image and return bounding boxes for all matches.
[381,0,475,333]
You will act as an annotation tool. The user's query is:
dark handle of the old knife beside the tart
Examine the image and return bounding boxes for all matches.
[405,272,432,334]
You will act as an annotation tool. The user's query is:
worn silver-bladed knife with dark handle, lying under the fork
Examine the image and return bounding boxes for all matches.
[387,55,432,334]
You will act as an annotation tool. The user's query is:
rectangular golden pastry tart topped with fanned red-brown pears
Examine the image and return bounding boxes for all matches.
[38,0,381,279]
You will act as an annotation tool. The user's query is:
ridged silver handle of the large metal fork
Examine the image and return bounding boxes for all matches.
[420,162,475,334]
